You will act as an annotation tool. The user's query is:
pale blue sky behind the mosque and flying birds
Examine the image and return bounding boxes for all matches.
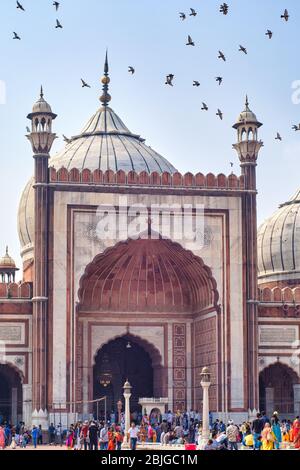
[0,0,300,272]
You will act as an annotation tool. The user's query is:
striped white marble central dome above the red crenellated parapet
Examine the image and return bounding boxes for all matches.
[49,106,176,173]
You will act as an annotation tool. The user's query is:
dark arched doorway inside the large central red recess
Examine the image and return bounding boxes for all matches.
[93,336,154,413]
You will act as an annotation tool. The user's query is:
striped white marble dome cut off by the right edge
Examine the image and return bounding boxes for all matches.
[258,190,300,284]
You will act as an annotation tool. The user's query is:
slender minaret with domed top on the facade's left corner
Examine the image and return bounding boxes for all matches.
[26,88,56,428]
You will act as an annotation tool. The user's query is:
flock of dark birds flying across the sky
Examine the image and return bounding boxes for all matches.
[13,1,300,141]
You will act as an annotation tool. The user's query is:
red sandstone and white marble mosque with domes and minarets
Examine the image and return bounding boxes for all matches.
[0,59,300,429]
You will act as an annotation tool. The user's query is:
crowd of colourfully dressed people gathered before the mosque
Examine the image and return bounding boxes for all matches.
[0,411,300,451]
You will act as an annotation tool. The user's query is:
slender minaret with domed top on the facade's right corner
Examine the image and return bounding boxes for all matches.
[233,96,263,410]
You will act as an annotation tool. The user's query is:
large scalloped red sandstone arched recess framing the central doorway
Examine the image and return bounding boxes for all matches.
[76,238,220,409]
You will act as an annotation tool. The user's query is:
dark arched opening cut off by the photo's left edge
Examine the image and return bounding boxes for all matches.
[0,364,23,424]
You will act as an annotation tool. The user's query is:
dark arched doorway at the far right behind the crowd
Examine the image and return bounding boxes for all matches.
[259,362,299,417]
